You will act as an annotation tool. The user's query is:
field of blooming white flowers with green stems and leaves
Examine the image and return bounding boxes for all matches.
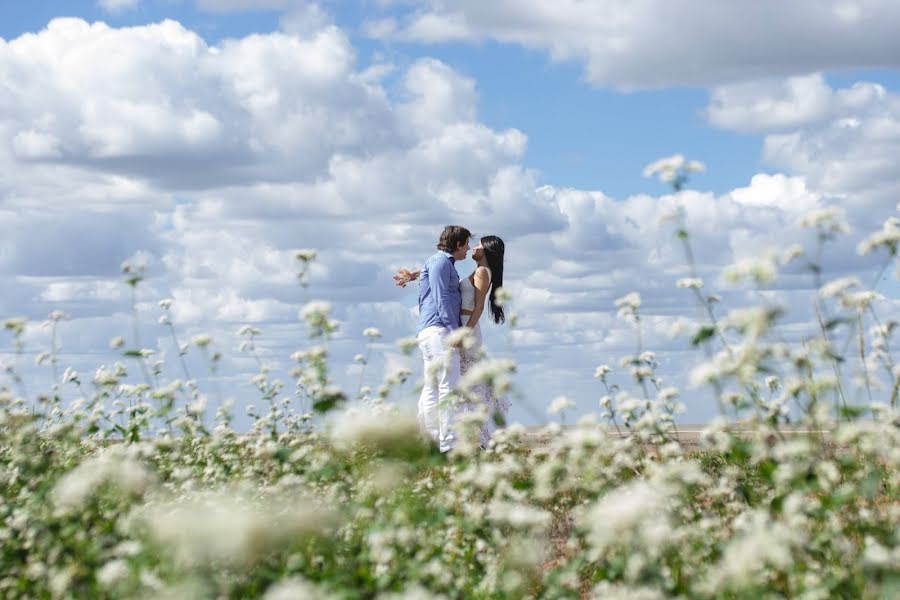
[0,159,900,600]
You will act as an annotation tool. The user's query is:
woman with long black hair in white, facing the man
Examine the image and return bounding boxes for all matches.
[394,235,509,448]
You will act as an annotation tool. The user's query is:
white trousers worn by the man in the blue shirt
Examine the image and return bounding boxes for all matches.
[417,326,459,452]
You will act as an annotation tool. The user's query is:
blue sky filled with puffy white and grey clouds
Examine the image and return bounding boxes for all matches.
[0,0,900,424]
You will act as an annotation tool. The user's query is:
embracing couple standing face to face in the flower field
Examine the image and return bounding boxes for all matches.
[396,225,509,452]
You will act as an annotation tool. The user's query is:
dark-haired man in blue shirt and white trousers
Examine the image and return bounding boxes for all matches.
[416,225,472,452]
